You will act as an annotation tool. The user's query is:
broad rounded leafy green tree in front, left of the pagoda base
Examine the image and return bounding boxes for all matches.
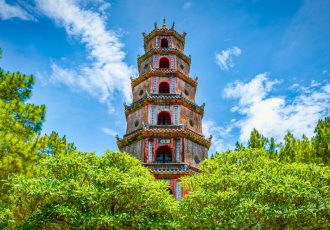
[7,151,176,229]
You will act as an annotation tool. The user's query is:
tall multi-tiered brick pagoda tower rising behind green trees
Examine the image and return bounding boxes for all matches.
[117,19,211,199]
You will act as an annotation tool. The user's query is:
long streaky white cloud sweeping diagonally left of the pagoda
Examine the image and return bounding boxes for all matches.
[36,0,135,111]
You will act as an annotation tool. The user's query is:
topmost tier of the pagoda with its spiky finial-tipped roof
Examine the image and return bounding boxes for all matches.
[142,18,187,52]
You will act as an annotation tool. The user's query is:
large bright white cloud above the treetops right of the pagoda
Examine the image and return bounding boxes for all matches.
[224,74,330,142]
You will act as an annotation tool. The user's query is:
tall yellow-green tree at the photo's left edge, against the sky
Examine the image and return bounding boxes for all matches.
[0,50,46,199]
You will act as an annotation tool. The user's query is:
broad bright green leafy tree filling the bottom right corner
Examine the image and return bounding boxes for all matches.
[179,149,330,229]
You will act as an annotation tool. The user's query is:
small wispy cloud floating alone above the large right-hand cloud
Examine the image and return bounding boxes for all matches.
[215,46,242,70]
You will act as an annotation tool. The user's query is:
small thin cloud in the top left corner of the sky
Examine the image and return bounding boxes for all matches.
[0,0,33,20]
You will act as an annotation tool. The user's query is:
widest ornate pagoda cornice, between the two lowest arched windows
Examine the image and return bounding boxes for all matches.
[117,125,212,149]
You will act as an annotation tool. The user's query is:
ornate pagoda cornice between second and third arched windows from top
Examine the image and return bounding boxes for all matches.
[131,68,197,90]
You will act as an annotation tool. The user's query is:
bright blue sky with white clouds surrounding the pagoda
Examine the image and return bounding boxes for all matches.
[0,0,330,154]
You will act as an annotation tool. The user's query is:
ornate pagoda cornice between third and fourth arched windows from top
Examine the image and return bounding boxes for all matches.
[124,93,205,117]
